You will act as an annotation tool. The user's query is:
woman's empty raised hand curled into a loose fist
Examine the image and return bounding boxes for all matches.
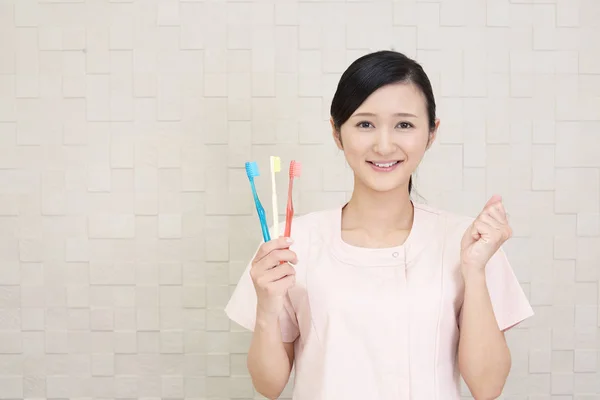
[460,195,512,275]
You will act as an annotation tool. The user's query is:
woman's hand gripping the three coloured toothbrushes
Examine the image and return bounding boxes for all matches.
[250,237,298,323]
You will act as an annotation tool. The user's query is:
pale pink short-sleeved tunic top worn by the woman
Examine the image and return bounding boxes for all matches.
[226,204,533,400]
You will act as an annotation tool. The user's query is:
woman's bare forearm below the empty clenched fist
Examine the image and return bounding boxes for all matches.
[458,269,511,400]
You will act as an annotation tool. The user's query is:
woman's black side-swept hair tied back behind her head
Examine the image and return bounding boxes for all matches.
[330,50,435,193]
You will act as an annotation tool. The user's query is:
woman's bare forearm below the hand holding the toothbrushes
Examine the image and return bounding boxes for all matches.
[248,317,294,399]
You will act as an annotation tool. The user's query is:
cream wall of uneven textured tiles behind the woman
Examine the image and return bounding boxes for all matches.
[0,0,600,400]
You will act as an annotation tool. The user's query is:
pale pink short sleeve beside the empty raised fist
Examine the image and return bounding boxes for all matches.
[485,249,533,331]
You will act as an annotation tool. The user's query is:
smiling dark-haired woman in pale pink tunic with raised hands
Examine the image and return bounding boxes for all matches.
[226,51,533,400]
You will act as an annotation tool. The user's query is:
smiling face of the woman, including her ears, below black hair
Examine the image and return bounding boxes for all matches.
[332,83,439,192]
